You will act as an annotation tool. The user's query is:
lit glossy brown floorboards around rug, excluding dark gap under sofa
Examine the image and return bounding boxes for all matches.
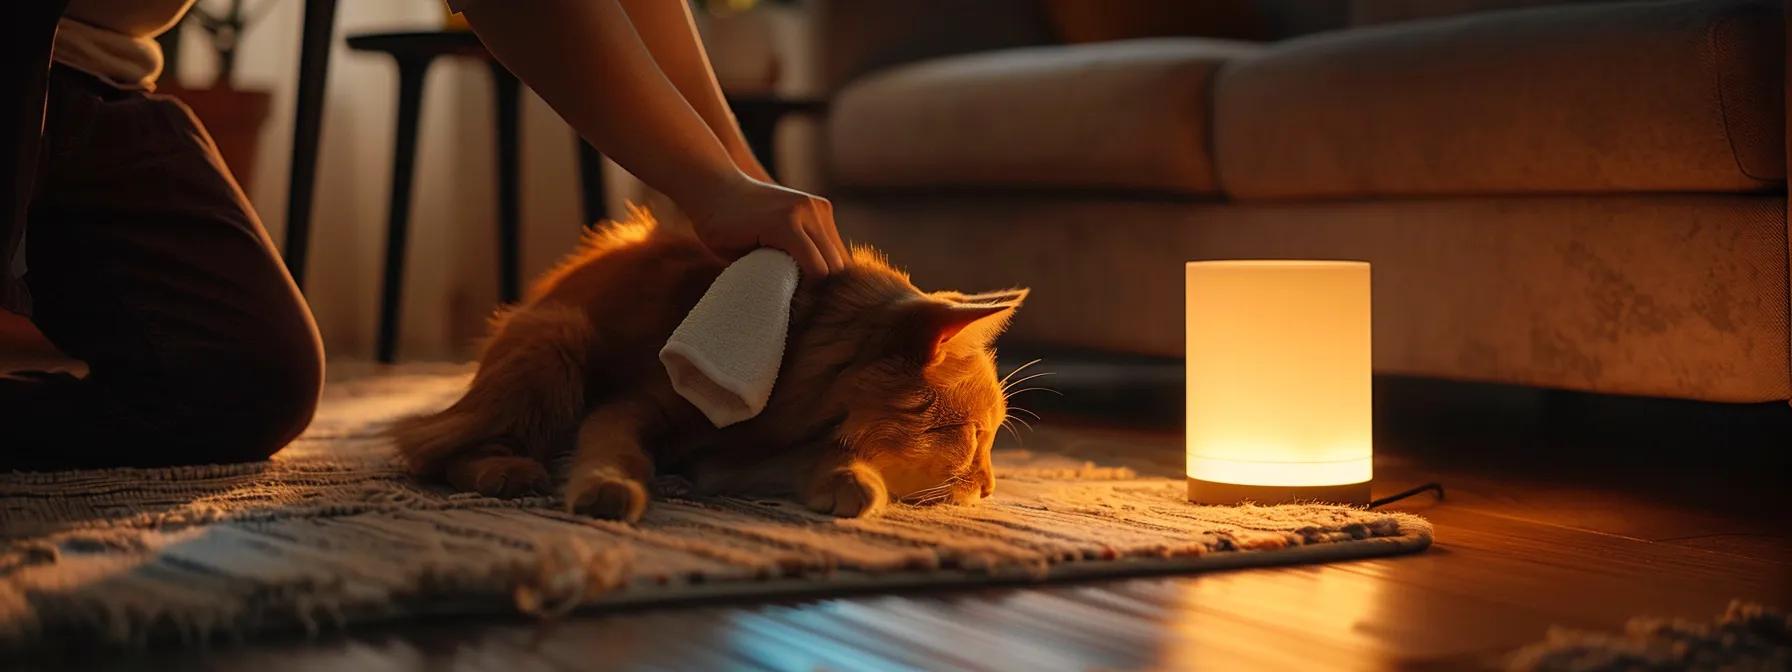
[24,410,1792,672]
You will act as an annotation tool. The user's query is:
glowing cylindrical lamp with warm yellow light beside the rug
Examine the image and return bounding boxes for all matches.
[1183,262,1373,504]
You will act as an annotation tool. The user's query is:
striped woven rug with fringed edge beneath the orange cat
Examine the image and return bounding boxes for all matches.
[0,367,1432,649]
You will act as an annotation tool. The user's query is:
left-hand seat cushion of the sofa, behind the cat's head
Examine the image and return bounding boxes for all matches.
[828,38,1262,195]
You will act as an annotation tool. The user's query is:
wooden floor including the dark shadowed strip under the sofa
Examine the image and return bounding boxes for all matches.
[0,335,1792,672]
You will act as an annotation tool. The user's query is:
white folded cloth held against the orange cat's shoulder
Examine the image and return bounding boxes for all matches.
[659,249,801,426]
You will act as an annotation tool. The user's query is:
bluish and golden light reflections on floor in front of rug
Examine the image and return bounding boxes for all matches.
[702,568,1398,670]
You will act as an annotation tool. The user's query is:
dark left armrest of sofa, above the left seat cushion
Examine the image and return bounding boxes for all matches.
[815,0,1057,95]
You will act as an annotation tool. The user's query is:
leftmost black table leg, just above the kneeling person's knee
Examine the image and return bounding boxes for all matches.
[285,0,337,289]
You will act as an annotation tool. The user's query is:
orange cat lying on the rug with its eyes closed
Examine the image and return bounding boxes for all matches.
[389,210,1027,521]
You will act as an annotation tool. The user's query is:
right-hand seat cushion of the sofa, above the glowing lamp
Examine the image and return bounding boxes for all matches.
[1215,0,1787,199]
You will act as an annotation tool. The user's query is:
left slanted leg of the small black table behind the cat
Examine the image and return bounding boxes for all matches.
[378,57,432,364]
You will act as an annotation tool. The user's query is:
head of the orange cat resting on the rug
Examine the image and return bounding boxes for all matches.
[780,247,1027,504]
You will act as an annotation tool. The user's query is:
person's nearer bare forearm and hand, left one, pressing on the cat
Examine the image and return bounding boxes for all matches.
[448,0,846,274]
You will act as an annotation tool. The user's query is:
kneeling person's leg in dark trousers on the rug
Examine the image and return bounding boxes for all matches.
[0,68,323,470]
